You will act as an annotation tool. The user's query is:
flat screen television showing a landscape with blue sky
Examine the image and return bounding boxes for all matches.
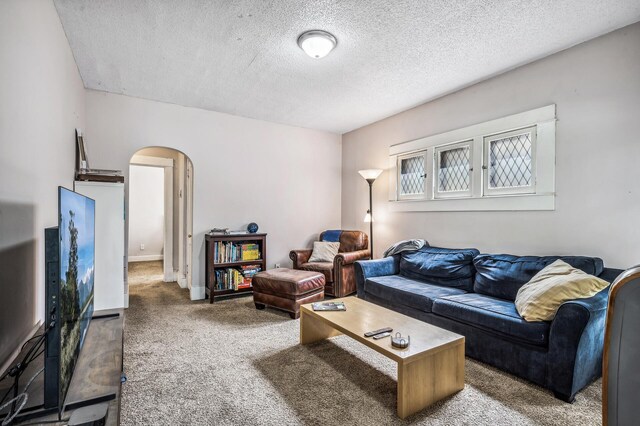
[44,187,95,412]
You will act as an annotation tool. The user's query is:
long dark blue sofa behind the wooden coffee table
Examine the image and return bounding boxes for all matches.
[355,247,622,402]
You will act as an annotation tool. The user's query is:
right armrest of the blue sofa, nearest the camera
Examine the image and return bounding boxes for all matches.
[547,287,609,402]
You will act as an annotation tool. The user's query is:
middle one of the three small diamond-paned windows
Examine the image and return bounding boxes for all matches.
[434,140,473,198]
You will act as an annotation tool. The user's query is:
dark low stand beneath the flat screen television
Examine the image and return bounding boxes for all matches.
[0,309,124,426]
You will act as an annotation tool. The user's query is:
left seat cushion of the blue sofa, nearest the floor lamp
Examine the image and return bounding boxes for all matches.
[365,275,465,312]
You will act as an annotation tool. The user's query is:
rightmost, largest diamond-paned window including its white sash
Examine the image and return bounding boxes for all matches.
[482,126,536,195]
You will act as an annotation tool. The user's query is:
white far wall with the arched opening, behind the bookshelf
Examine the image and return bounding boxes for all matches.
[85,90,342,298]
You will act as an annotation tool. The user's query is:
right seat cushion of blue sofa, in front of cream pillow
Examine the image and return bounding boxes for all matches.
[432,293,549,346]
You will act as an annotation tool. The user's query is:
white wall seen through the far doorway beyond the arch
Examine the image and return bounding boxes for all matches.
[129,165,164,261]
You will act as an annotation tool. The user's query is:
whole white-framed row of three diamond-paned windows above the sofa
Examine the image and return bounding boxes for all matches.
[388,104,556,212]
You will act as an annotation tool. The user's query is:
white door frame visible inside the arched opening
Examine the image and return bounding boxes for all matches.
[129,154,176,282]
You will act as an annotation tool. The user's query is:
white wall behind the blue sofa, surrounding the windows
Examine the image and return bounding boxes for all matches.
[342,23,640,268]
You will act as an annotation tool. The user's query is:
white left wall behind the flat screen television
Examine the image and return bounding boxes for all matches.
[0,0,85,370]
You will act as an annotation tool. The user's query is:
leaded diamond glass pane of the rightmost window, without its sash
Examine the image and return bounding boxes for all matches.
[489,132,533,188]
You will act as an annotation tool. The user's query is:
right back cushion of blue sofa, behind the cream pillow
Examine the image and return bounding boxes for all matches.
[473,254,604,301]
